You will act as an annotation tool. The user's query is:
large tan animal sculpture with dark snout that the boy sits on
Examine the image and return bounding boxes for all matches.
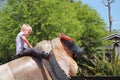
[0,35,82,80]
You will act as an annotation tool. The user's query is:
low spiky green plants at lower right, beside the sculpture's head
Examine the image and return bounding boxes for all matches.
[78,51,120,76]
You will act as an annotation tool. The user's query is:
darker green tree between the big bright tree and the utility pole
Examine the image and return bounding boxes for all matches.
[78,5,108,55]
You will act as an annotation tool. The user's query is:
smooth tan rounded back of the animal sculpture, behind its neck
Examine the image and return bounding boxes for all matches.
[0,57,52,80]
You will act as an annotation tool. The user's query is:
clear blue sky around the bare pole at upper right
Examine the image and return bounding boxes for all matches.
[75,0,120,30]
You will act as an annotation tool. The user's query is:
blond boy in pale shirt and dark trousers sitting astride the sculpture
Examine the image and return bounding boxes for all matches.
[16,24,52,60]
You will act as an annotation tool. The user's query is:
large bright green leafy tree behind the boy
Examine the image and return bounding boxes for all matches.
[0,0,82,62]
